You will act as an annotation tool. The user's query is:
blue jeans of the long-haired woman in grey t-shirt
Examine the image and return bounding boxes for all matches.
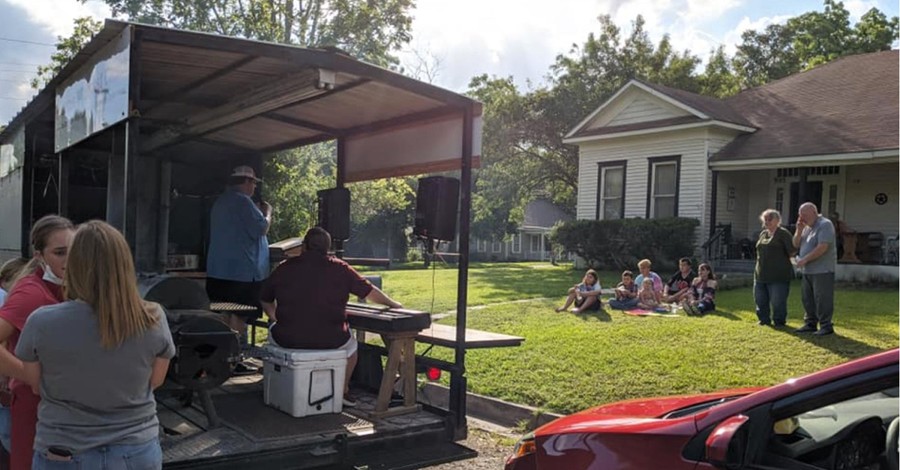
[31,439,162,470]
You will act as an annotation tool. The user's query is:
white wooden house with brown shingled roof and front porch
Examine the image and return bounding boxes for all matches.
[564,51,900,280]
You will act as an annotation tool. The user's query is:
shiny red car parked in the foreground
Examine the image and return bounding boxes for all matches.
[506,349,900,470]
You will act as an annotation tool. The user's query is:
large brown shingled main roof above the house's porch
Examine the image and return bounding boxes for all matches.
[710,50,900,163]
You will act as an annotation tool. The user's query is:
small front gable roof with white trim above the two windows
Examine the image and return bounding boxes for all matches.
[563,79,754,143]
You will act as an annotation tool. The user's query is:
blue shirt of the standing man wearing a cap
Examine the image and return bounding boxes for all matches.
[206,187,269,282]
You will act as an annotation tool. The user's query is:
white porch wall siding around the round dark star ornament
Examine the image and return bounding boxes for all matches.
[841,163,900,237]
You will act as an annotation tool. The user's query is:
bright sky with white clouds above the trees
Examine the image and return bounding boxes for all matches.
[0,0,898,123]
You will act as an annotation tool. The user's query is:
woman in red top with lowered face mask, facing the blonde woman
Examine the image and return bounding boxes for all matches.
[0,215,75,470]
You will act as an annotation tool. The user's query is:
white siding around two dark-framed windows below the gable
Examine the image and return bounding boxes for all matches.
[577,129,707,219]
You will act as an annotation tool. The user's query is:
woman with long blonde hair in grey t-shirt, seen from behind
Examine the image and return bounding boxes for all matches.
[16,221,175,469]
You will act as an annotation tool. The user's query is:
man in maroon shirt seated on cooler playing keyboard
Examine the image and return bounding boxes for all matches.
[260,227,402,407]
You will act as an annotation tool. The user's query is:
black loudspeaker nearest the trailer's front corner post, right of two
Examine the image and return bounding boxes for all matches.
[413,176,459,241]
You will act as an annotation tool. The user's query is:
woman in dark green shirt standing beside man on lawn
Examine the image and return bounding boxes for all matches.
[753,209,794,326]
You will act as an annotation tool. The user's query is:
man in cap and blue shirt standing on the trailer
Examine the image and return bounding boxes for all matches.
[206,166,272,374]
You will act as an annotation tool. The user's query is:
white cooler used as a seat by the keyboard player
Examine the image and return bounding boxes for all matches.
[263,344,347,418]
